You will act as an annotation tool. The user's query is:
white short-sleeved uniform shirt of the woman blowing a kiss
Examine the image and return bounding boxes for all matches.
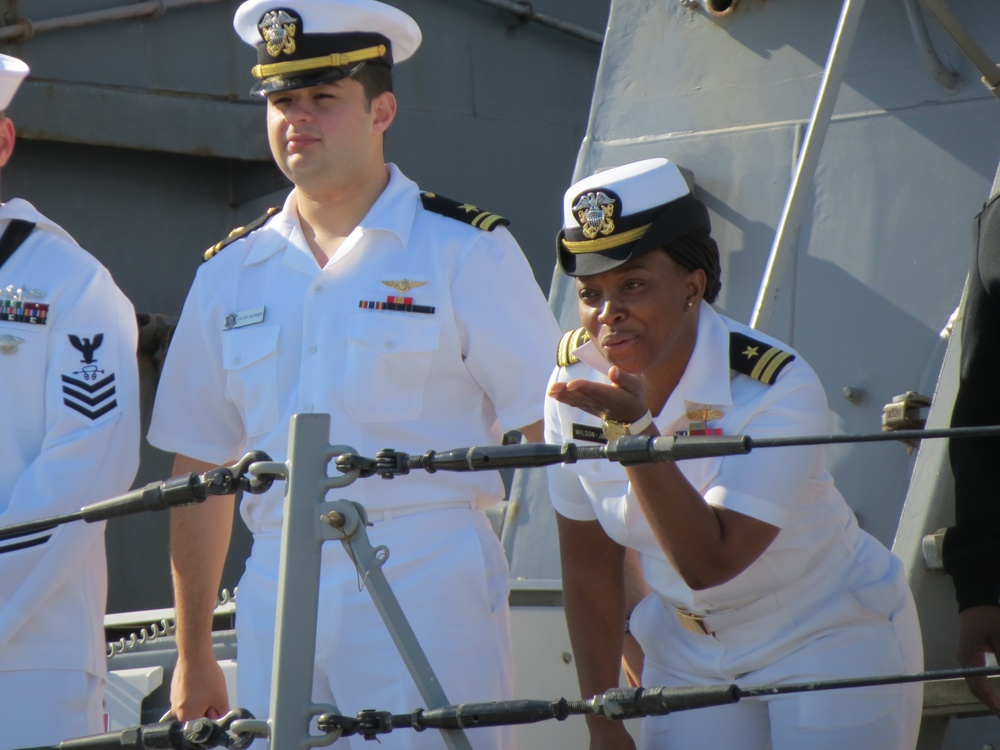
[545,302,859,612]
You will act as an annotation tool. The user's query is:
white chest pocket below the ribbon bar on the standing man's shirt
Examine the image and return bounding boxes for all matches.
[344,312,441,422]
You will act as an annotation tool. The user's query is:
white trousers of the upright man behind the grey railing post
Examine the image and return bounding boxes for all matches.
[236,508,514,750]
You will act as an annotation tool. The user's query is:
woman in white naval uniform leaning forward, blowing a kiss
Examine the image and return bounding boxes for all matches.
[545,159,922,750]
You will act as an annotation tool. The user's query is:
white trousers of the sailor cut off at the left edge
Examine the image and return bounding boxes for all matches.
[0,669,105,750]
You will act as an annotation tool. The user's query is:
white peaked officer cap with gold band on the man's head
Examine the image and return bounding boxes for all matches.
[233,0,421,95]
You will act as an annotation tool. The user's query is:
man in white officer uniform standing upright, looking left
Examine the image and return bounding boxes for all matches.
[149,0,560,749]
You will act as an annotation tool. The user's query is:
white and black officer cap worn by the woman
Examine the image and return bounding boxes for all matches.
[556,158,711,276]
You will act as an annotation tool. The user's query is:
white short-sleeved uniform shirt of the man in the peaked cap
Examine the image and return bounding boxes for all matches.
[149,165,559,533]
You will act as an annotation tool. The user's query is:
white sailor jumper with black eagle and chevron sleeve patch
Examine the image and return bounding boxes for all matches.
[0,199,139,676]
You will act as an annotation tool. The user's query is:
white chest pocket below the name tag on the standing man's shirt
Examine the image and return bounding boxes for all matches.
[222,326,281,437]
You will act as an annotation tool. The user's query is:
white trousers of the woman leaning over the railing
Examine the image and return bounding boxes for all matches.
[631,535,923,750]
